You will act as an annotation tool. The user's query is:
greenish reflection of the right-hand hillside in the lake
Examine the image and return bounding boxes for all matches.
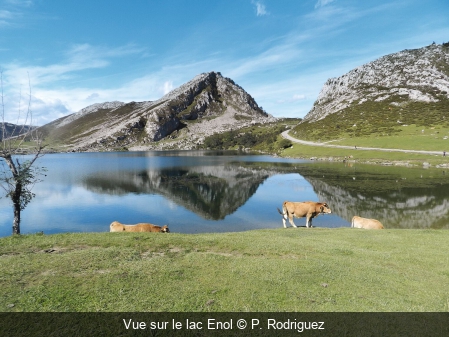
[270,164,449,229]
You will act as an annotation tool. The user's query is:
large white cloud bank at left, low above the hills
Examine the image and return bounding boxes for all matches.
[2,44,150,125]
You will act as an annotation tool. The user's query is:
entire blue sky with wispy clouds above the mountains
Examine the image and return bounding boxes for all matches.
[0,0,449,125]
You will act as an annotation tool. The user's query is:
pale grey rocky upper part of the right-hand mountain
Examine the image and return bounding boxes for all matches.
[304,43,449,122]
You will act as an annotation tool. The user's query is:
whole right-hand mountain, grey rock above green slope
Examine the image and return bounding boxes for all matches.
[296,43,449,139]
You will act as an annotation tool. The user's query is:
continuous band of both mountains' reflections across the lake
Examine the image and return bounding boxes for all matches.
[85,158,449,228]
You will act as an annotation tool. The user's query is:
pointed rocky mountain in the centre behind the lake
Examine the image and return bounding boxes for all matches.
[40,72,275,151]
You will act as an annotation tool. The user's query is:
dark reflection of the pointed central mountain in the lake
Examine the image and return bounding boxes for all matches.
[84,165,269,220]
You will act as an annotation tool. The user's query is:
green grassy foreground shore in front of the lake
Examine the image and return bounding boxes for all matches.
[0,228,449,312]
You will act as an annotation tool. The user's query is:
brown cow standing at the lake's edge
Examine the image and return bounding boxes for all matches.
[278,201,332,228]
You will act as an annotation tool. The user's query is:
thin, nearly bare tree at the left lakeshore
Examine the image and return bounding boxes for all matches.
[0,70,46,234]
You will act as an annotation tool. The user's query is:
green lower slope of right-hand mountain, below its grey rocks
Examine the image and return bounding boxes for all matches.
[293,96,449,142]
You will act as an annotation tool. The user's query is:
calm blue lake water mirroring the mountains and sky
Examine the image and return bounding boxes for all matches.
[0,151,449,236]
